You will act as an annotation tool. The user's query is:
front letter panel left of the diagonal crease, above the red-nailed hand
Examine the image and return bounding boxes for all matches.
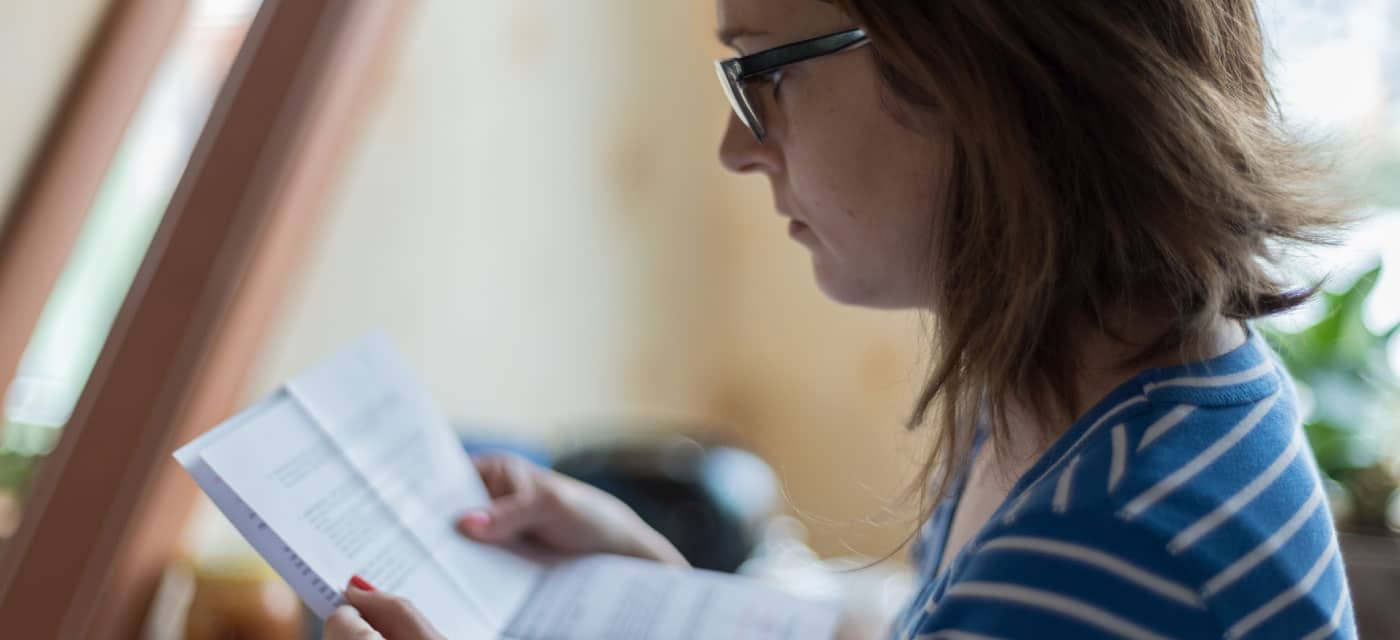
[191,395,500,637]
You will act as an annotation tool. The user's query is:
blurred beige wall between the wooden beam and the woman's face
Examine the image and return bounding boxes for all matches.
[249,0,917,553]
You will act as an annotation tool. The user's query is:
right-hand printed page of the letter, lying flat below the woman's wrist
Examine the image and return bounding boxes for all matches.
[505,556,837,640]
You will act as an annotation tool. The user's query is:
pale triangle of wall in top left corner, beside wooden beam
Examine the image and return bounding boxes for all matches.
[0,0,108,224]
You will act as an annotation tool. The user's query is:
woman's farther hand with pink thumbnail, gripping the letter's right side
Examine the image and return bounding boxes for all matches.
[456,455,689,565]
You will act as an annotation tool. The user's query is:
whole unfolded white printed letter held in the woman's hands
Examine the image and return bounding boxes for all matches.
[175,336,836,640]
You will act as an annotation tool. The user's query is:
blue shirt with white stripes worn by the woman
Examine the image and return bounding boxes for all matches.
[893,332,1357,639]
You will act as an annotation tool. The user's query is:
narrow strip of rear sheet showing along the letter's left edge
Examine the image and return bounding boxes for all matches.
[175,396,344,618]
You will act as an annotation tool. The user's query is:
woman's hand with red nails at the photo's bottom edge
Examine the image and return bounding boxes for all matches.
[322,578,445,640]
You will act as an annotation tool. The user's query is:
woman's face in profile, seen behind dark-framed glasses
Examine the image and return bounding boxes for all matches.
[717,0,951,308]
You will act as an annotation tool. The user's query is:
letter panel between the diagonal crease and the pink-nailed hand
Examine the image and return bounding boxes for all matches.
[287,336,543,629]
